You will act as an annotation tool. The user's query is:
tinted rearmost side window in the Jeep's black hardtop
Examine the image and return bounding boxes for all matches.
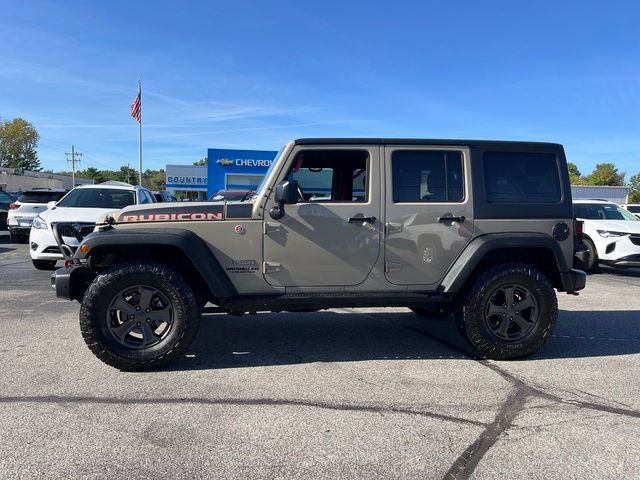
[483,152,562,203]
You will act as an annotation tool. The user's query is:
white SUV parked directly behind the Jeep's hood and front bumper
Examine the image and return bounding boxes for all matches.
[29,181,155,270]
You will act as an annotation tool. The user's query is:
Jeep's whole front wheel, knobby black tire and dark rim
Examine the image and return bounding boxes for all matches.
[80,262,202,370]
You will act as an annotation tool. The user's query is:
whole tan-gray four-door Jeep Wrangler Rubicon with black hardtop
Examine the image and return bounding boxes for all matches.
[52,139,586,370]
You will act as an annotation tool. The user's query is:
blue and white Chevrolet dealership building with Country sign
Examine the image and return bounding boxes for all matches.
[166,148,278,200]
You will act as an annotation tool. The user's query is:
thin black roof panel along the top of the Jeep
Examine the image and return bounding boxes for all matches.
[294,138,562,148]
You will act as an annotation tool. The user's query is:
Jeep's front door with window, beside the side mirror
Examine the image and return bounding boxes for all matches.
[263,145,381,287]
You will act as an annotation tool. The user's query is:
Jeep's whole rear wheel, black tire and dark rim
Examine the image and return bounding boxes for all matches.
[457,264,558,360]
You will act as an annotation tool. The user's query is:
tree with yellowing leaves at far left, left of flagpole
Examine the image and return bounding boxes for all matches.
[0,117,42,172]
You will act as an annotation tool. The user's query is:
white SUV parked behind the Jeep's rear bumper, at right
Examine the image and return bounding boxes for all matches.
[573,200,640,271]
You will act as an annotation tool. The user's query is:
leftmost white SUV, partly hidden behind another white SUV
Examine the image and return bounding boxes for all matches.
[7,188,69,243]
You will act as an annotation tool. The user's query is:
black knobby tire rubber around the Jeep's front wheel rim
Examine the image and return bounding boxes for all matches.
[80,261,202,370]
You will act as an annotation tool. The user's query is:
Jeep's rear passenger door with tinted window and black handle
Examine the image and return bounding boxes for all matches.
[384,145,473,285]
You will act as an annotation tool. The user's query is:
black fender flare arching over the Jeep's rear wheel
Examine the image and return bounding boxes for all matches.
[440,232,571,293]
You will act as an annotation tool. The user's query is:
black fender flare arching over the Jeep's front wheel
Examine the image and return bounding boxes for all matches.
[74,228,237,298]
